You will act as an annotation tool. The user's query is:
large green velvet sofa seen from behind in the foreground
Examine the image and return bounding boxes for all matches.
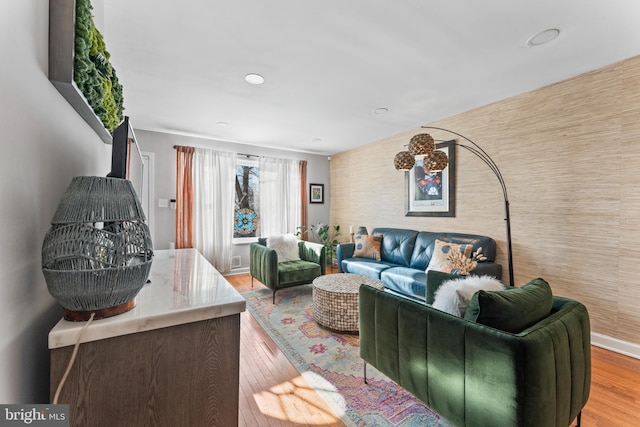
[359,277,591,427]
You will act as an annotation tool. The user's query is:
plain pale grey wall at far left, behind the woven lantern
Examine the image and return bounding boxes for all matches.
[0,0,111,403]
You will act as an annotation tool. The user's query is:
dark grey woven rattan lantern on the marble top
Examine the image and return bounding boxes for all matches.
[42,176,153,320]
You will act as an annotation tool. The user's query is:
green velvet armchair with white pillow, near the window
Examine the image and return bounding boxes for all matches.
[249,238,326,304]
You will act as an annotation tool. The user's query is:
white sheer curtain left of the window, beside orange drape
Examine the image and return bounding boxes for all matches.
[193,148,236,273]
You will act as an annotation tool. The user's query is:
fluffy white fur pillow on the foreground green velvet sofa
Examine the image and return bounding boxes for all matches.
[433,276,504,317]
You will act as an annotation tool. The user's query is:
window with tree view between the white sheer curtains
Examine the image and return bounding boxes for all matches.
[233,158,260,238]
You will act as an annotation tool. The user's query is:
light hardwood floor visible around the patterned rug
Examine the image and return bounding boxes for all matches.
[226,274,640,427]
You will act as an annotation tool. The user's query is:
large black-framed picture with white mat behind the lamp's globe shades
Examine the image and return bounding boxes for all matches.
[405,140,456,217]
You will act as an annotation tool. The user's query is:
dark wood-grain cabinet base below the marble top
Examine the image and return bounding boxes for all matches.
[50,314,240,427]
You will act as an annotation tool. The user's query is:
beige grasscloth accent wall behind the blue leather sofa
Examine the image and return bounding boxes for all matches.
[330,56,640,344]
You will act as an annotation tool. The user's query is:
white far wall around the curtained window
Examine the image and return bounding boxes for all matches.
[131,130,330,268]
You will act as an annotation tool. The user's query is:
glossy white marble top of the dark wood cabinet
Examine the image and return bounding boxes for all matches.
[49,249,246,349]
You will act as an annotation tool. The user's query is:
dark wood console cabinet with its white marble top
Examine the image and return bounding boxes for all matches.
[49,249,246,427]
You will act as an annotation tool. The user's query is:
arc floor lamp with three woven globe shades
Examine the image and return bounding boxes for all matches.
[394,126,514,286]
